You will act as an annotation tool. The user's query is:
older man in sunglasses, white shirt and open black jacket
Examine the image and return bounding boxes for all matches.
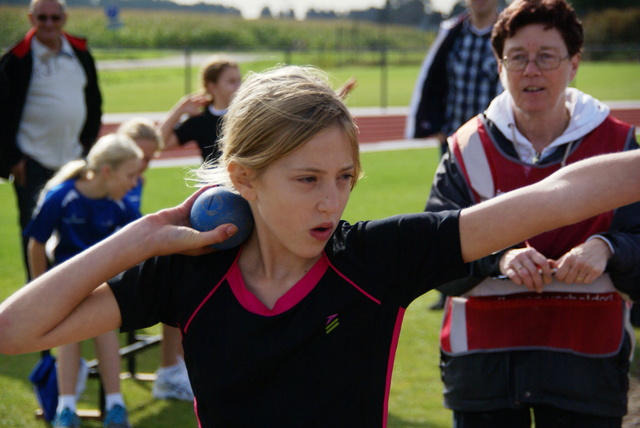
[0,0,102,280]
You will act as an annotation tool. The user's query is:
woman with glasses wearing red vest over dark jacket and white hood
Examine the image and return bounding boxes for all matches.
[426,0,640,428]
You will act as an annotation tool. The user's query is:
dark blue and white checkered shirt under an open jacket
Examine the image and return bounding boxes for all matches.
[442,18,502,135]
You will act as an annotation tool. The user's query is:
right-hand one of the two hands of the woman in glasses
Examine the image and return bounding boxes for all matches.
[555,238,612,284]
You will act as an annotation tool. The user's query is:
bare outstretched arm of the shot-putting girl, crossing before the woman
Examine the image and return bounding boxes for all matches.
[460,150,640,262]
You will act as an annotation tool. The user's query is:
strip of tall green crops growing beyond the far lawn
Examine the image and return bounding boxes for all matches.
[0,6,433,50]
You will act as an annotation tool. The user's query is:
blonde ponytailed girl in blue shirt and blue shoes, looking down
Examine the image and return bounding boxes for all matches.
[25,134,142,428]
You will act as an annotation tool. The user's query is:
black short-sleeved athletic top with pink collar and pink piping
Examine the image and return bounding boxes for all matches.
[110,212,468,427]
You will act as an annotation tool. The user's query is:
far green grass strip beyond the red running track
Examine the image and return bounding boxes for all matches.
[100,59,640,113]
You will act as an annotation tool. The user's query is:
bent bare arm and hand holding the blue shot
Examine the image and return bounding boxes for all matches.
[0,191,236,354]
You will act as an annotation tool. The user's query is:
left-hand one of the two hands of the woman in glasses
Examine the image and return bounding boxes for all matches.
[500,247,553,293]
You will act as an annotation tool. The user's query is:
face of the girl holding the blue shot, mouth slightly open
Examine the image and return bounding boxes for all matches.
[243,126,354,258]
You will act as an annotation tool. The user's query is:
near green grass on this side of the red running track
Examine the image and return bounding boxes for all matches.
[0,148,450,428]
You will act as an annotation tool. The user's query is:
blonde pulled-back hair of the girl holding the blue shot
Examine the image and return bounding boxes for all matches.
[196,66,362,187]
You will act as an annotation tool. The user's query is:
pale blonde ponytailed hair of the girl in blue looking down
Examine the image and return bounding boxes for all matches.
[40,134,143,197]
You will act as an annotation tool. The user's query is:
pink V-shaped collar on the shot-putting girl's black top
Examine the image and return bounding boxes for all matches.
[227,253,329,316]
